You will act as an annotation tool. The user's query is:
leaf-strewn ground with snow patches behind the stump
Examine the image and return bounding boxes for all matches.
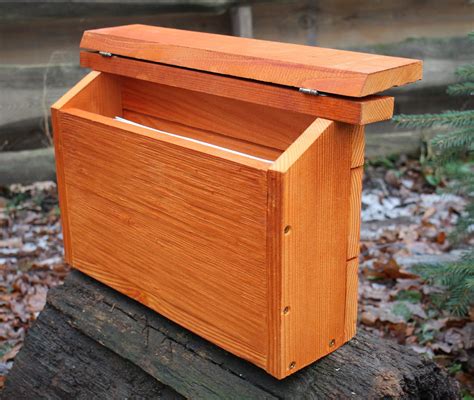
[0,157,474,399]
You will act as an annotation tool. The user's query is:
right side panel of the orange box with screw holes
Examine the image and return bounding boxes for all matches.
[268,119,351,378]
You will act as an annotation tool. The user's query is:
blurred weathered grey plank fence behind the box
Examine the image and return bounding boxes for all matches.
[0,0,474,184]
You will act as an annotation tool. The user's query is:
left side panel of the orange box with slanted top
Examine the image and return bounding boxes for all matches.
[51,72,122,263]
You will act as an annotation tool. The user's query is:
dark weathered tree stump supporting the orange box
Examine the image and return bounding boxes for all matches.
[2,271,459,400]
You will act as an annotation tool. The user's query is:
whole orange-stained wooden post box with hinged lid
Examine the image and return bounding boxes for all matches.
[52,25,421,378]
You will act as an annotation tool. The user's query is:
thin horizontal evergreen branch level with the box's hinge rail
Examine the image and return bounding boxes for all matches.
[393,110,474,128]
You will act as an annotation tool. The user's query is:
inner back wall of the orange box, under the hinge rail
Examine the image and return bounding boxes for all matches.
[122,78,314,150]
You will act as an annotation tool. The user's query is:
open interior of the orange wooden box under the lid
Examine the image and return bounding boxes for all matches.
[62,73,315,166]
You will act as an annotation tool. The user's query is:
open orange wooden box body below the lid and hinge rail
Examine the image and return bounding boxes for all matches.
[51,72,362,378]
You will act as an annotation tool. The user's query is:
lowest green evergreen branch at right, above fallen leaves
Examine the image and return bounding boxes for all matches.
[413,250,474,316]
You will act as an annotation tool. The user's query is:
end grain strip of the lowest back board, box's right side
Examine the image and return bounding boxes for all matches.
[344,257,359,342]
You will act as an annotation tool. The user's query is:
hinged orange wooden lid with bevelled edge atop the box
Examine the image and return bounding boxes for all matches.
[81,25,422,97]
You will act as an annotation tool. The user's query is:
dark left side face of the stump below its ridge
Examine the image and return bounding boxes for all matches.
[1,306,183,400]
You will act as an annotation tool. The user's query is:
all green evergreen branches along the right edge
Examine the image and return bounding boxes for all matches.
[394,32,474,315]
